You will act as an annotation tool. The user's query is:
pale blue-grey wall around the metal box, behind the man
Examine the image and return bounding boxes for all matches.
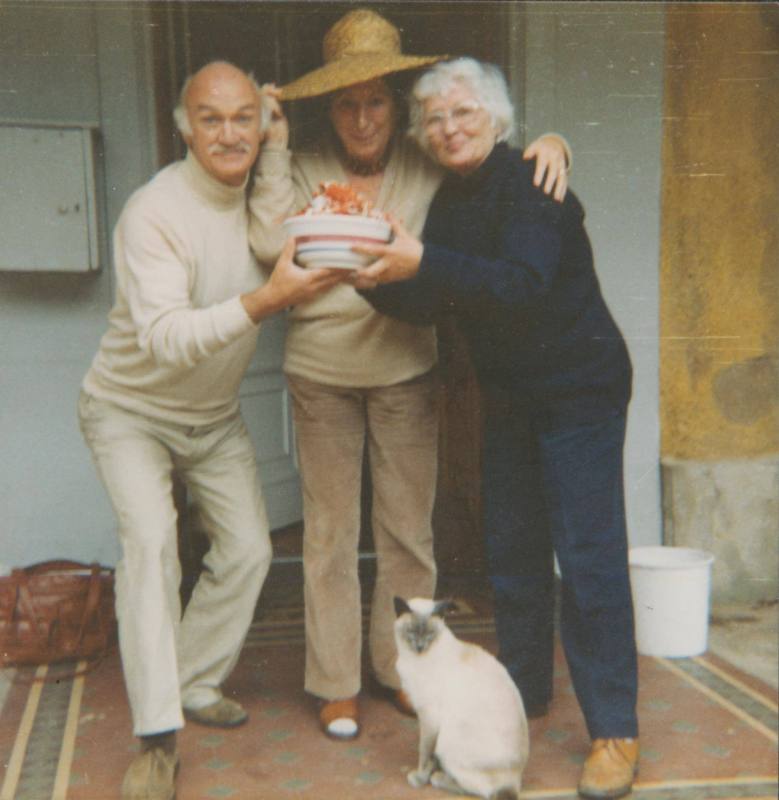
[0,2,160,566]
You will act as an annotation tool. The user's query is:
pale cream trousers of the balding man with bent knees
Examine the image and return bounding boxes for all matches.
[79,392,271,736]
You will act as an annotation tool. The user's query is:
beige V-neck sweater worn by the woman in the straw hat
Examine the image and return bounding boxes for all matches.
[249,139,442,387]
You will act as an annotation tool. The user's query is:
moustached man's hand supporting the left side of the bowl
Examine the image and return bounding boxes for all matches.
[241,239,349,324]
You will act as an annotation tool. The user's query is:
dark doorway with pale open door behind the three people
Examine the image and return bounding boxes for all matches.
[155,2,517,575]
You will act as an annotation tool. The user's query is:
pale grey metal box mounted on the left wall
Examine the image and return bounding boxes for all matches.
[0,122,100,272]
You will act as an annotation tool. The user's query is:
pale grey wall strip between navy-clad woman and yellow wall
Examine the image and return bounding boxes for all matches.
[512,2,664,545]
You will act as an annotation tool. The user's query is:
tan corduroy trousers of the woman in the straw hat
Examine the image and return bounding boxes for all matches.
[287,373,438,700]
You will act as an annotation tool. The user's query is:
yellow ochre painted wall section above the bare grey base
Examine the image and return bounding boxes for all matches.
[662,4,779,461]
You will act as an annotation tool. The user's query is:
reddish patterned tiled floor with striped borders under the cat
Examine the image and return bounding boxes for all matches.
[0,599,777,800]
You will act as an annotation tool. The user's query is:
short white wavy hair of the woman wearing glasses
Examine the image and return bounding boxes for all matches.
[408,58,514,153]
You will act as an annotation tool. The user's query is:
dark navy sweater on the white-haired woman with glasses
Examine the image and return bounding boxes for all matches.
[363,144,632,428]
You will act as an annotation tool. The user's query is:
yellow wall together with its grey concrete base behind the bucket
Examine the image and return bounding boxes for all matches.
[661,3,779,602]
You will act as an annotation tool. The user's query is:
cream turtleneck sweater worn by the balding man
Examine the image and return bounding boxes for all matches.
[83,153,264,425]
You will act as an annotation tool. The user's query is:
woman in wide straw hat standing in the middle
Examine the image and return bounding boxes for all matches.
[250,9,567,739]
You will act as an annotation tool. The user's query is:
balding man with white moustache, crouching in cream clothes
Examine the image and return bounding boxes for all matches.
[79,62,342,800]
